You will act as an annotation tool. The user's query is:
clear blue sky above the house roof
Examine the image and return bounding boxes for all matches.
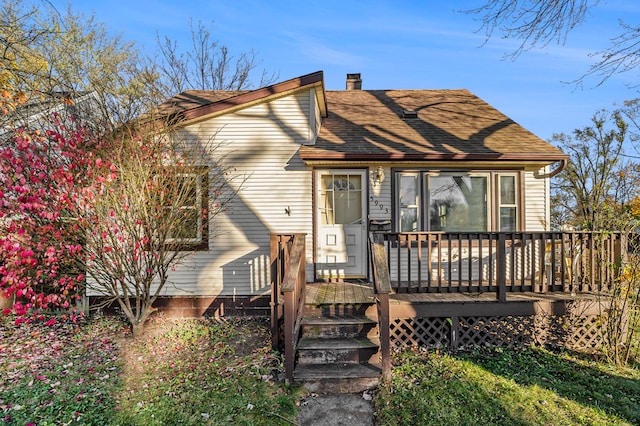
[45,0,640,139]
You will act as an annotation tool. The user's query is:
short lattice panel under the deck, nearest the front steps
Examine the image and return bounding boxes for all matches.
[390,318,451,348]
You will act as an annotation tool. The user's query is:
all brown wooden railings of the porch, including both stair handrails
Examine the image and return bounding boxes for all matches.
[271,232,627,382]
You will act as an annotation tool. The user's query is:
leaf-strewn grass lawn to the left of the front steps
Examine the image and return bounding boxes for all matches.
[0,318,299,425]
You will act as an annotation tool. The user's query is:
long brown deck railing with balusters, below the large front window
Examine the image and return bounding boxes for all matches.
[384,232,626,300]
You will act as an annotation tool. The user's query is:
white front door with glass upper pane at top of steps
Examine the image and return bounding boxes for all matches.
[316,170,367,278]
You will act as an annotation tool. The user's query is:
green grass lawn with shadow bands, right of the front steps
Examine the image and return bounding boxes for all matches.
[375,348,640,426]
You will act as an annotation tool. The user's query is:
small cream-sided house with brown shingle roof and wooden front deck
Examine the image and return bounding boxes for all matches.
[151,72,624,392]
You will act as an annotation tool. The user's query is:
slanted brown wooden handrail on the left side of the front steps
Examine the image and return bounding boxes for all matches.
[280,234,306,383]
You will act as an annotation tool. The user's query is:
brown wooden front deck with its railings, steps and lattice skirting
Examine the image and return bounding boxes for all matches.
[271,233,625,383]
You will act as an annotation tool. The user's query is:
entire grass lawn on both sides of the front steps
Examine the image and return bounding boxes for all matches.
[0,318,640,426]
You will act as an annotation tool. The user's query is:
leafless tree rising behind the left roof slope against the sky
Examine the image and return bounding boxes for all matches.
[156,21,276,98]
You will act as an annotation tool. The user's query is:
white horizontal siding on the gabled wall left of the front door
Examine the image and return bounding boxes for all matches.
[158,91,316,296]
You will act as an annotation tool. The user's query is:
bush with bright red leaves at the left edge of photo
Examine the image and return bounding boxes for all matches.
[0,116,113,322]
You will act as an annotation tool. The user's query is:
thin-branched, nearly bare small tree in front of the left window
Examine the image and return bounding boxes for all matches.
[79,120,235,335]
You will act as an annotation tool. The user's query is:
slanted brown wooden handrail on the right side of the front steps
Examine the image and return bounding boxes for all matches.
[369,233,391,382]
